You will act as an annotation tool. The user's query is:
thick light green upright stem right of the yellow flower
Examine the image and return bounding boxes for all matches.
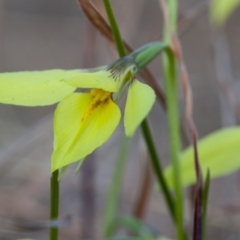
[163,0,186,240]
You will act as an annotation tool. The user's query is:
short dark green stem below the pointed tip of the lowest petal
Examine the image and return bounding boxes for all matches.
[49,170,59,240]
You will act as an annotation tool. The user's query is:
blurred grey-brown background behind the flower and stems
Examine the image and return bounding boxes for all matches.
[0,0,240,240]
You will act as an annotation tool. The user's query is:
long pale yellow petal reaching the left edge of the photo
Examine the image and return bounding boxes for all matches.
[0,69,79,106]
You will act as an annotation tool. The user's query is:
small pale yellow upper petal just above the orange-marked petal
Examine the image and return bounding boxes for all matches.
[65,70,122,92]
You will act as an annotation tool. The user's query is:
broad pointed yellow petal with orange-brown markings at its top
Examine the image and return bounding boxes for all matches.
[52,93,121,171]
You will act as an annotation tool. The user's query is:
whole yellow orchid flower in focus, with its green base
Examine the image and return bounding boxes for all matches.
[0,43,165,172]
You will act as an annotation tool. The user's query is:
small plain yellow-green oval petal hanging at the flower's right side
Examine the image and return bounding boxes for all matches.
[124,79,155,136]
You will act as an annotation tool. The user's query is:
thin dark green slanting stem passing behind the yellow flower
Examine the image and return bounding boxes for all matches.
[103,0,175,222]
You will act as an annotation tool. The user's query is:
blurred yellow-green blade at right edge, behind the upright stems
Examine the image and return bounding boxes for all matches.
[164,127,240,189]
